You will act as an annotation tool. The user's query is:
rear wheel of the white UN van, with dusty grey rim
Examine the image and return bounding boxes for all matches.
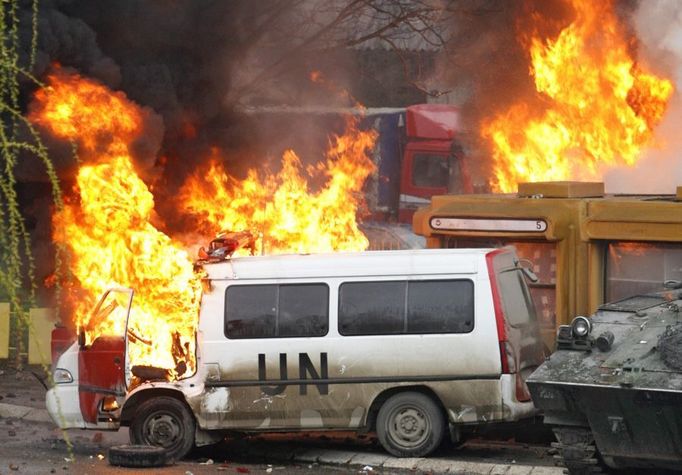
[376,391,445,457]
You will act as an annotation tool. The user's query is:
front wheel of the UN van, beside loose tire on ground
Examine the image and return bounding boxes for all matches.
[130,396,196,461]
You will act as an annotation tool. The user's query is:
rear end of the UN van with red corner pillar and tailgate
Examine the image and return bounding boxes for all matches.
[486,247,545,402]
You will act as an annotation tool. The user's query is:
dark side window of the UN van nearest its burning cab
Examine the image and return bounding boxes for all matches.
[225,284,329,339]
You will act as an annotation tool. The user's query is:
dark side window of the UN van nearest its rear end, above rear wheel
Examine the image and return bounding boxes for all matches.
[339,280,474,336]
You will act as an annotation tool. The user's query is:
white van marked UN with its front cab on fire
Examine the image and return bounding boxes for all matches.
[47,248,544,459]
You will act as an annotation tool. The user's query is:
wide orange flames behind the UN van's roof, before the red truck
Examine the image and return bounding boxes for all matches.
[180,119,376,254]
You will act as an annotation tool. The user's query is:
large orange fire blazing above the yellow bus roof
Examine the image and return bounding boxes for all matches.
[483,0,673,192]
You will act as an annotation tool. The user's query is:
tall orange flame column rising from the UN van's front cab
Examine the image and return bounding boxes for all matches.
[30,69,200,377]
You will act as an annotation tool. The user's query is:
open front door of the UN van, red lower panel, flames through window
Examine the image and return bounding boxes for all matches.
[78,289,133,424]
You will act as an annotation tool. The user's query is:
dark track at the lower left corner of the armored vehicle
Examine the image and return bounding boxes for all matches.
[552,427,602,475]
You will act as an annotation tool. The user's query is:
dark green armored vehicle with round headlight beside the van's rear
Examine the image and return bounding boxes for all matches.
[527,282,682,474]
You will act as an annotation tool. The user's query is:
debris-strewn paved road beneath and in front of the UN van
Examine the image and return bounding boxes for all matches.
[0,369,562,475]
